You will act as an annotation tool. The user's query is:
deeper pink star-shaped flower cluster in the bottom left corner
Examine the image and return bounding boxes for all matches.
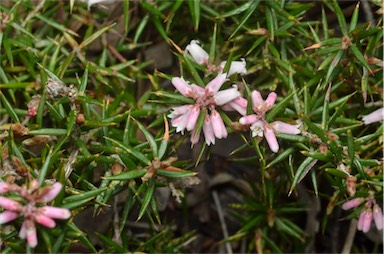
[0,180,71,248]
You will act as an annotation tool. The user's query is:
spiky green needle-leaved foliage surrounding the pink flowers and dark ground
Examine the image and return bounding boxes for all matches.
[0,0,383,253]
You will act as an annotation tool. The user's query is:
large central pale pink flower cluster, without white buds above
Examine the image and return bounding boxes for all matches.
[168,73,240,145]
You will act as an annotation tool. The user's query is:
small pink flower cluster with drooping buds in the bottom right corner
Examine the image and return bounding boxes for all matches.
[342,196,383,233]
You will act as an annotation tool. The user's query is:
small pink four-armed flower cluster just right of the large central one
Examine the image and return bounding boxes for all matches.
[239,91,300,153]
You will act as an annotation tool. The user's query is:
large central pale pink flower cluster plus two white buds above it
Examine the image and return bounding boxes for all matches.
[168,40,247,145]
